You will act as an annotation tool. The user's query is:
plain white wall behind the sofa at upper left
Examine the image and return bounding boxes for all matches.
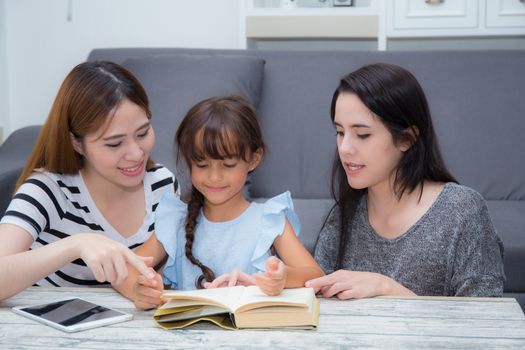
[0,0,242,137]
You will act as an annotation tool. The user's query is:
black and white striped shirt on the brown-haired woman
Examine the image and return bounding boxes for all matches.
[0,165,178,287]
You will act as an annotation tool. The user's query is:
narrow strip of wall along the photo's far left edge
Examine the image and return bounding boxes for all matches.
[0,0,9,143]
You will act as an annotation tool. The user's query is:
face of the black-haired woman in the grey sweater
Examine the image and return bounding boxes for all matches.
[334,93,409,193]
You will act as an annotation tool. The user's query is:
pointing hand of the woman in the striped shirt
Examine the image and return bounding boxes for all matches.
[71,233,155,285]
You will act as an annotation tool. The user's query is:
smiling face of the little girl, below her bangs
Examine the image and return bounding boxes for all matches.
[191,150,262,208]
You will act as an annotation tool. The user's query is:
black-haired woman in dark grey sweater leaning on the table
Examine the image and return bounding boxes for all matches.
[306,64,505,299]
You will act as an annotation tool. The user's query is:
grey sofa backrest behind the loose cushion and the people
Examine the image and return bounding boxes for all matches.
[89,48,525,201]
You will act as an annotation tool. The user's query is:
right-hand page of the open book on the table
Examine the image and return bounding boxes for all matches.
[234,286,315,312]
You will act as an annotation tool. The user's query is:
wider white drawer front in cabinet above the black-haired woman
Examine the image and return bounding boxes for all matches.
[393,0,476,30]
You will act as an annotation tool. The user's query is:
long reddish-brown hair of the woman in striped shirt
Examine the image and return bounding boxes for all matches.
[15,61,154,191]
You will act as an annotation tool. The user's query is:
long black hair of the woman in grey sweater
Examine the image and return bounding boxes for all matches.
[330,63,457,269]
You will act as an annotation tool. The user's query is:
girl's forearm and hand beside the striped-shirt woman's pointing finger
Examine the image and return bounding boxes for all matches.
[113,234,166,309]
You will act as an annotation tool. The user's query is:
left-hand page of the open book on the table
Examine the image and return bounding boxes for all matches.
[159,286,244,311]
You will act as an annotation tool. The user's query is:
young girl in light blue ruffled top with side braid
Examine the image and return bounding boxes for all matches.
[117,96,323,308]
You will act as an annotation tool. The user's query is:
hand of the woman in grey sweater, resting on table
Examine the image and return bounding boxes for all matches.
[305,270,396,299]
